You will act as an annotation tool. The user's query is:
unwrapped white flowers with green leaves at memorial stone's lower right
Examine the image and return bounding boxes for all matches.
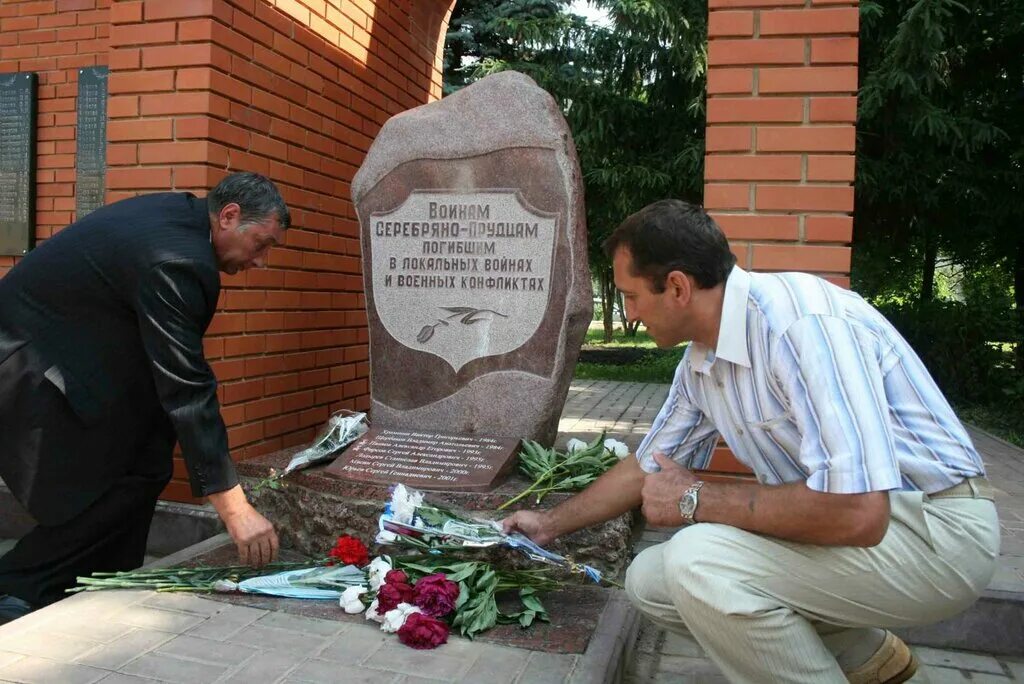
[498,432,630,510]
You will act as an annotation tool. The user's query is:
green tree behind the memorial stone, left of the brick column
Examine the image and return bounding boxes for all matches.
[452,0,708,340]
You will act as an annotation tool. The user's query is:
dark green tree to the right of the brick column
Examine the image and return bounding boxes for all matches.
[853,0,1024,370]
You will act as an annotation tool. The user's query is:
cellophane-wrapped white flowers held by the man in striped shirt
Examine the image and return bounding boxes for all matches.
[377,484,601,583]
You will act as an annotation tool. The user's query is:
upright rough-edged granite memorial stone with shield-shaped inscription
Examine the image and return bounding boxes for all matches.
[352,72,593,450]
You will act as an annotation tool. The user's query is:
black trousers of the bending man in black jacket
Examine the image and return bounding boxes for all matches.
[0,472,169,606]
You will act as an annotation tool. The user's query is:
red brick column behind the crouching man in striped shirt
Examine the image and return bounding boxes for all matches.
[705,0,858,287]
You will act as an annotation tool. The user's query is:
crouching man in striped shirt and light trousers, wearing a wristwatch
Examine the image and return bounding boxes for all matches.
[505,201,999,683]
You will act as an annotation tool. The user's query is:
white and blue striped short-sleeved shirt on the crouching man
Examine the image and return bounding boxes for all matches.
[637,267,984,494]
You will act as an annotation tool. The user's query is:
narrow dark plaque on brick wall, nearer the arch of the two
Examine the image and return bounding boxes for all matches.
[75,67,110,220]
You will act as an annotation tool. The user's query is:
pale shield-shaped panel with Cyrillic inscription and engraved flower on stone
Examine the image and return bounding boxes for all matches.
[370,190,557,371]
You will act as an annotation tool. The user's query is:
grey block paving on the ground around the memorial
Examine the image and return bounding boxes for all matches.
[0,381,1024,684]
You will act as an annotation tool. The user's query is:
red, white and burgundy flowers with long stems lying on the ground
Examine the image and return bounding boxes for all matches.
[69,535,564,648]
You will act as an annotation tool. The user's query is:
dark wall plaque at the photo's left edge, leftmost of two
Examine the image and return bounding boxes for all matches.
[0,73,37,256]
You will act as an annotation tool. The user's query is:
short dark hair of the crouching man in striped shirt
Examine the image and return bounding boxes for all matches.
[604,200,736,292]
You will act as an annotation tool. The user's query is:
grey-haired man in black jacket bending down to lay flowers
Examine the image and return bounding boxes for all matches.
[0,173,289,624]
